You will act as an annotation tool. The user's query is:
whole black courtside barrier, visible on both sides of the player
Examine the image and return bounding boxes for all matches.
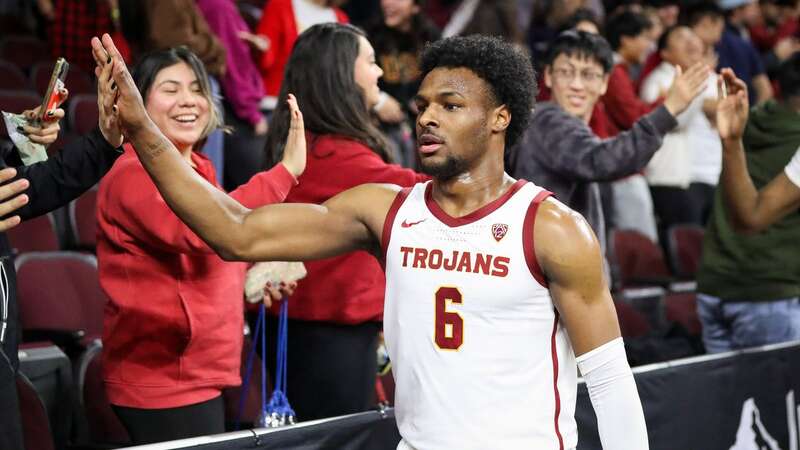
[131,343,800,450]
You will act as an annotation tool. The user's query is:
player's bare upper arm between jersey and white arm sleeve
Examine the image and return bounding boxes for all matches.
[533,199,620,355]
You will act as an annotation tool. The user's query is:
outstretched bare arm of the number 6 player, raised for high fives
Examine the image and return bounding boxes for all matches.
[92,35,384,261]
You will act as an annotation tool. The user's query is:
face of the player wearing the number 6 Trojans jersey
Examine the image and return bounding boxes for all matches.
[414,67,498,179]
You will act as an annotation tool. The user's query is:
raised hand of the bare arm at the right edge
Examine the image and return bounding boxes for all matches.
[717,69,750,140]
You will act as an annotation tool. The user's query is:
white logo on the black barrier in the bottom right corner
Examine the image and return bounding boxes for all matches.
[730,391,800,450]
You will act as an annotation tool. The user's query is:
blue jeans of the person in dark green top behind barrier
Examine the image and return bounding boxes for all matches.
[697,294,800,353]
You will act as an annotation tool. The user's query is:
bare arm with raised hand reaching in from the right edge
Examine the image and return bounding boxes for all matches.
[717,69,800,236]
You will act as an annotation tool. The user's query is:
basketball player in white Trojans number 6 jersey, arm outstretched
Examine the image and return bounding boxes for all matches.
[93,35,648,450]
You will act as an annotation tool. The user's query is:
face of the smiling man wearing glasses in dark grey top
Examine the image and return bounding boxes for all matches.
[544,54,608,122]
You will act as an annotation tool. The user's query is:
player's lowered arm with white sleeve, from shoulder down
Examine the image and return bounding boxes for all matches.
[533,200,649,450]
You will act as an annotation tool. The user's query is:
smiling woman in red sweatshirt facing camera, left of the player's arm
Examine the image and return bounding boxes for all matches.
[97,47,305,444]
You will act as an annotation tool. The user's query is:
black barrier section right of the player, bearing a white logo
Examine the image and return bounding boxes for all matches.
[576,343,800,450]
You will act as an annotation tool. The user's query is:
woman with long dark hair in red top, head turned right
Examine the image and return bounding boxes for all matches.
[266,23,425,420]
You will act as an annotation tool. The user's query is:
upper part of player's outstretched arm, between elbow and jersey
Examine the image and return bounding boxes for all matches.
[224,184,400,261]
